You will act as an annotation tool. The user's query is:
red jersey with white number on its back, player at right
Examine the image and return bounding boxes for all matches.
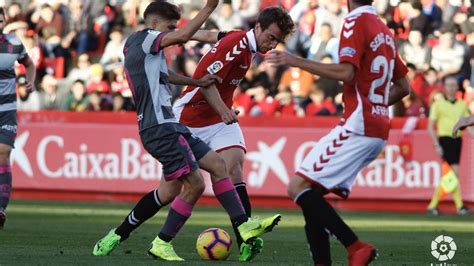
[339,6,408,139]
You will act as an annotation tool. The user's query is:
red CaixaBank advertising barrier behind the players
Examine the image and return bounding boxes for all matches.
[12,112,474,212]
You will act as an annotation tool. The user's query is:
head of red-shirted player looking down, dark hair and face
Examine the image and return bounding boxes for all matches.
[255,7,295,53]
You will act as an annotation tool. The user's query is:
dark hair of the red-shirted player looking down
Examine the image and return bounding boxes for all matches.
[257,6,295,37]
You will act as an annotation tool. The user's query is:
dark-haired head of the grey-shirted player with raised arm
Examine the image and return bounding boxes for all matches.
[143,0,181,32]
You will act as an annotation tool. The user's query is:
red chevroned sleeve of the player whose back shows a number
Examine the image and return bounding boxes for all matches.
[339,18,365,68]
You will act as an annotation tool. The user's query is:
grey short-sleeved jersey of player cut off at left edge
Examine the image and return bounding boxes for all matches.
[0,34,27,112]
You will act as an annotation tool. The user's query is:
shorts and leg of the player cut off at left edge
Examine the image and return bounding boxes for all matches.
[0,111,17,230]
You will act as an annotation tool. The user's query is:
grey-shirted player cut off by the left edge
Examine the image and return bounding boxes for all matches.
[0,7,36,229]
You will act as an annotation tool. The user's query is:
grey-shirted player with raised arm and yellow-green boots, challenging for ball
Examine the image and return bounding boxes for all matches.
[93,0,281,261]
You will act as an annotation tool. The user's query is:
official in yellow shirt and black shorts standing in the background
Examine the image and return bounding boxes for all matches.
[427,75,471,215]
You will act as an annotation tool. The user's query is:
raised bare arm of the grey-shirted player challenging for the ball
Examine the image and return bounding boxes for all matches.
[160,0,219,48]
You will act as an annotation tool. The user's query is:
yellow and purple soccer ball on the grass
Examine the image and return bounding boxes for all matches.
[196,228,232,260]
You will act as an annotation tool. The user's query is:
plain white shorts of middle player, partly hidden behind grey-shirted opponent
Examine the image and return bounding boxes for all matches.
[188,122,247,152]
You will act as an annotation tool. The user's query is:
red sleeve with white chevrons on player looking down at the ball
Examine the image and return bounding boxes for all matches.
[199,34,249,79]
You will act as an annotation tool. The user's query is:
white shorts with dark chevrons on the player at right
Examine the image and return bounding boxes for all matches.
[296,126,385,198]
